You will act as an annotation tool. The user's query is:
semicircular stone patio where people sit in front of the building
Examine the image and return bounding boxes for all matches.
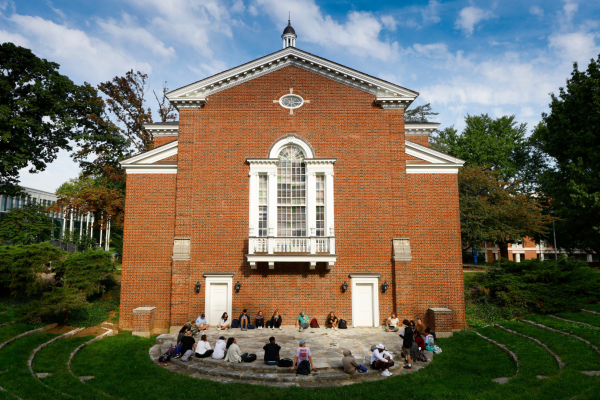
[150,326,433,387]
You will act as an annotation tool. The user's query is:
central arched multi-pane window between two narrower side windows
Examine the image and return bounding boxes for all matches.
[277,145,306,237]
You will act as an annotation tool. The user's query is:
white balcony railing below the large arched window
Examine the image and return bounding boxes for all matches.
[248,236,335,254]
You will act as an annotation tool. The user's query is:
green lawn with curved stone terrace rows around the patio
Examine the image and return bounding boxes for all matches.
[0,310,600,400]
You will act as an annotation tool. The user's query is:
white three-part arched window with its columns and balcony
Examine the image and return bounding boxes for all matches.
[246,135,337,268]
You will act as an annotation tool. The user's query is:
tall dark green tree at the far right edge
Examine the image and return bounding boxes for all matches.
[533,56,600,254]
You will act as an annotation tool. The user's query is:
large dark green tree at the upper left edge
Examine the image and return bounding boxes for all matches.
[0,43,77,194]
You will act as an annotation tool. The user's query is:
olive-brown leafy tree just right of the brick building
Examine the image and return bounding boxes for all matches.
[458,165,550,258]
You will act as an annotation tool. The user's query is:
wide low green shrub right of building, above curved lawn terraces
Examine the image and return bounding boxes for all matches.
[467,259,600,316]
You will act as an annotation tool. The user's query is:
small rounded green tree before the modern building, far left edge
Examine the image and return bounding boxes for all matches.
[0,204,54,244]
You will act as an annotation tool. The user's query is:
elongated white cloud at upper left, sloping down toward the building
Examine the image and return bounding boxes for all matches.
[8,14,152,81]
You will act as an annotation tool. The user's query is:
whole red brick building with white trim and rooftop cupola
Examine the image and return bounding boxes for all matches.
[120,23,465,333]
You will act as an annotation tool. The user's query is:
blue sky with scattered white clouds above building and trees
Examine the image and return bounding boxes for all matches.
[0,0,600,191]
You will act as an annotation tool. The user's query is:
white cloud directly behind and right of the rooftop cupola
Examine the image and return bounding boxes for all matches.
[255,0,398,60]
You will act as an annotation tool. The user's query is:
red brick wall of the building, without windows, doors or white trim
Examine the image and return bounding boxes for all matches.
[121,67,464,327]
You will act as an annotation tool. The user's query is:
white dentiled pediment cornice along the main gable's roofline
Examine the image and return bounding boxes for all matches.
[167,47,419,108]
